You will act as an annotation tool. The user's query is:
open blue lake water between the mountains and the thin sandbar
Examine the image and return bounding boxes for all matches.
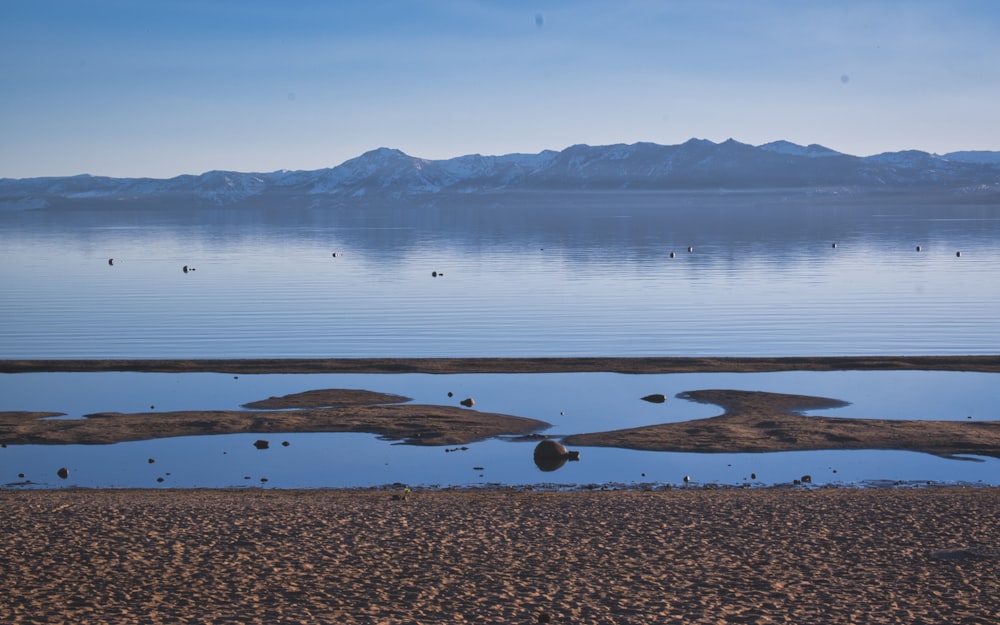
[0,195,1000,358]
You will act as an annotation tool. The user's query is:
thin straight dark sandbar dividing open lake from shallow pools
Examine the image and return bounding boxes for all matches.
[0,354,1000,374]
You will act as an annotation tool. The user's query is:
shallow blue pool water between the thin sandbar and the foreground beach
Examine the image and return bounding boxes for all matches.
[0,371,1000,488]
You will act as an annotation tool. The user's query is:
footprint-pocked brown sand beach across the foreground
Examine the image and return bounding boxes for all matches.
[0,488,1000,625]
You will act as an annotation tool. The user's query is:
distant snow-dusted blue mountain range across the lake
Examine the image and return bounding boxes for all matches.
[0,139,1000,210]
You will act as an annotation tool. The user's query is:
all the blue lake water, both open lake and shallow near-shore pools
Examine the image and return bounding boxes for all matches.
[0,193,1000,487]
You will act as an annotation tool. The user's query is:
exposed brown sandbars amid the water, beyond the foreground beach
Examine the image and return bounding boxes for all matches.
[0,356,1000,458]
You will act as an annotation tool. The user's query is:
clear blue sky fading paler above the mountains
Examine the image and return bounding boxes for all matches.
[0,0,1000,178]
